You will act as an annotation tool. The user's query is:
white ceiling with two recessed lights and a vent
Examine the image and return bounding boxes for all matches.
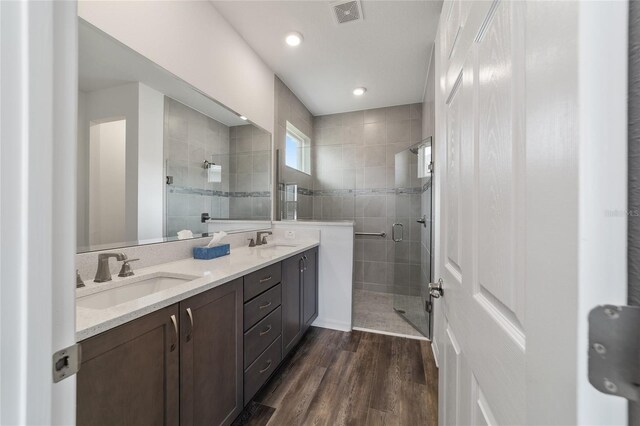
[212,0,442,115]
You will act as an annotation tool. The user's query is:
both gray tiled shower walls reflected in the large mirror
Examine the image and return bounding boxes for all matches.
[164,97,271,237]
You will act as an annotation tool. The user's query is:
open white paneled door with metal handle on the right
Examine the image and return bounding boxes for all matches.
[434,1,626,425]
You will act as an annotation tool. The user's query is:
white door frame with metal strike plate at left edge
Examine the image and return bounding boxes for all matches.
[0,1,78,425]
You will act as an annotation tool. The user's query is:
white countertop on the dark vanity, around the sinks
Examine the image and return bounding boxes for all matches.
[76,241,320,342]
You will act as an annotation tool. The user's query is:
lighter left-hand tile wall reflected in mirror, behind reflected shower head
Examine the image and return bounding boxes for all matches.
[164,96,229,237]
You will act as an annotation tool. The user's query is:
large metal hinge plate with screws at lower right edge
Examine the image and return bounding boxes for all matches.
[589,305,640,402]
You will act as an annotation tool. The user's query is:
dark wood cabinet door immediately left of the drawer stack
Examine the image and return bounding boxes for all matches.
[180,278,243,426]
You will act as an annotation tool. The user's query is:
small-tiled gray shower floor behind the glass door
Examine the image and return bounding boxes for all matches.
[353,290,425,339]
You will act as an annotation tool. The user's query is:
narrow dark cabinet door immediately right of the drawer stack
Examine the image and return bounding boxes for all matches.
[282,255,302,358]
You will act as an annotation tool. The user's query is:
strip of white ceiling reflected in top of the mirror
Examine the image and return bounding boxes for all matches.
[78,19,248,126]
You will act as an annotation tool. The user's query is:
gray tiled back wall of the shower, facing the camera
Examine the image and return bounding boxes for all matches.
[311,104,422,295]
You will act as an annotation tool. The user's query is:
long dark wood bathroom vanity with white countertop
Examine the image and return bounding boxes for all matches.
[77,241,318,425]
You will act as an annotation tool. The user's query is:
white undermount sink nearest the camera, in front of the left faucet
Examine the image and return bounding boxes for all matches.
[76,272,199,309]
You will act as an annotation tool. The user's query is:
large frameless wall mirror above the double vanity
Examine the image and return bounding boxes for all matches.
[77,19,272,253]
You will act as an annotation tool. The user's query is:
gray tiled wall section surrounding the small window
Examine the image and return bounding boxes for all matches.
[274,77,315,219]
